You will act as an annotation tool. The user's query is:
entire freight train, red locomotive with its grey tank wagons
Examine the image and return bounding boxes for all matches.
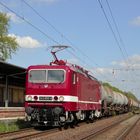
[25,45,138,126]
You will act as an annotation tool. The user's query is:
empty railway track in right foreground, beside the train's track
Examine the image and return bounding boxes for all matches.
[81,115,140,140]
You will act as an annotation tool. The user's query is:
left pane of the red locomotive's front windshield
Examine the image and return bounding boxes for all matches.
[29,70,46,83]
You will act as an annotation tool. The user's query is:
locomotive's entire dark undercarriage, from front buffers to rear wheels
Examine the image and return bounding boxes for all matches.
[26,107,101,128]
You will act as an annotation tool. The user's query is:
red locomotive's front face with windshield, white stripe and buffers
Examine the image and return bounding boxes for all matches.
[25,66,73,126]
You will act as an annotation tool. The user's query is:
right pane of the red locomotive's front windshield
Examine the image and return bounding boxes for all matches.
[47,70,64,83]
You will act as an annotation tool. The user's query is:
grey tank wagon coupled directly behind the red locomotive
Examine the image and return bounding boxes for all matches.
[101,85,128,116]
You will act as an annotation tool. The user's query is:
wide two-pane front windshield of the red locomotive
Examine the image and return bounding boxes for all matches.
[29,70,64,83]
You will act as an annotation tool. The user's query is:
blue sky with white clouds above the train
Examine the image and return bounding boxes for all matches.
[0,0,140,99]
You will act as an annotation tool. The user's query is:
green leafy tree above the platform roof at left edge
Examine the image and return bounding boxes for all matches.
[0,12,18,60]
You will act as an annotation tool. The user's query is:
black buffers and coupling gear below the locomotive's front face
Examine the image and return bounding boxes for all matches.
[26,107,73,126]
